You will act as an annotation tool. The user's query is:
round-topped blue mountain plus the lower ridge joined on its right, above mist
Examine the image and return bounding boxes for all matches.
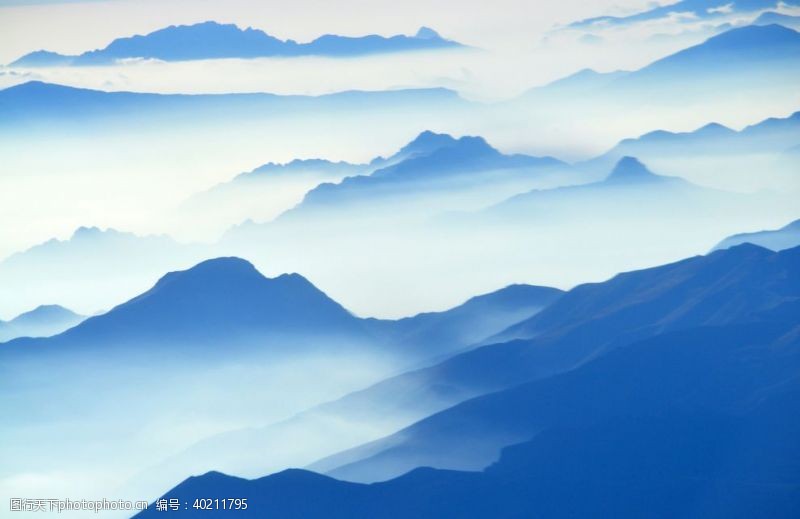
[5,255,560,368]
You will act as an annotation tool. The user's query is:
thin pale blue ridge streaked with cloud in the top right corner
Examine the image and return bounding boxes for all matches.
[568,0,800,29]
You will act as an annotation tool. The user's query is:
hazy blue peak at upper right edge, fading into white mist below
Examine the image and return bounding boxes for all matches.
[509,24,800,110]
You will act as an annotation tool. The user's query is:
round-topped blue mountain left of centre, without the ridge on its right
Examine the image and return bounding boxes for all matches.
[0,258,364,353]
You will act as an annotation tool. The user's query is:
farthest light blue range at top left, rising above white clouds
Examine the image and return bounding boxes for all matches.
[10,21,465,67]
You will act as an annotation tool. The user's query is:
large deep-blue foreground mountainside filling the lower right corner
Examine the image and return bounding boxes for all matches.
[139,245,800,518]
